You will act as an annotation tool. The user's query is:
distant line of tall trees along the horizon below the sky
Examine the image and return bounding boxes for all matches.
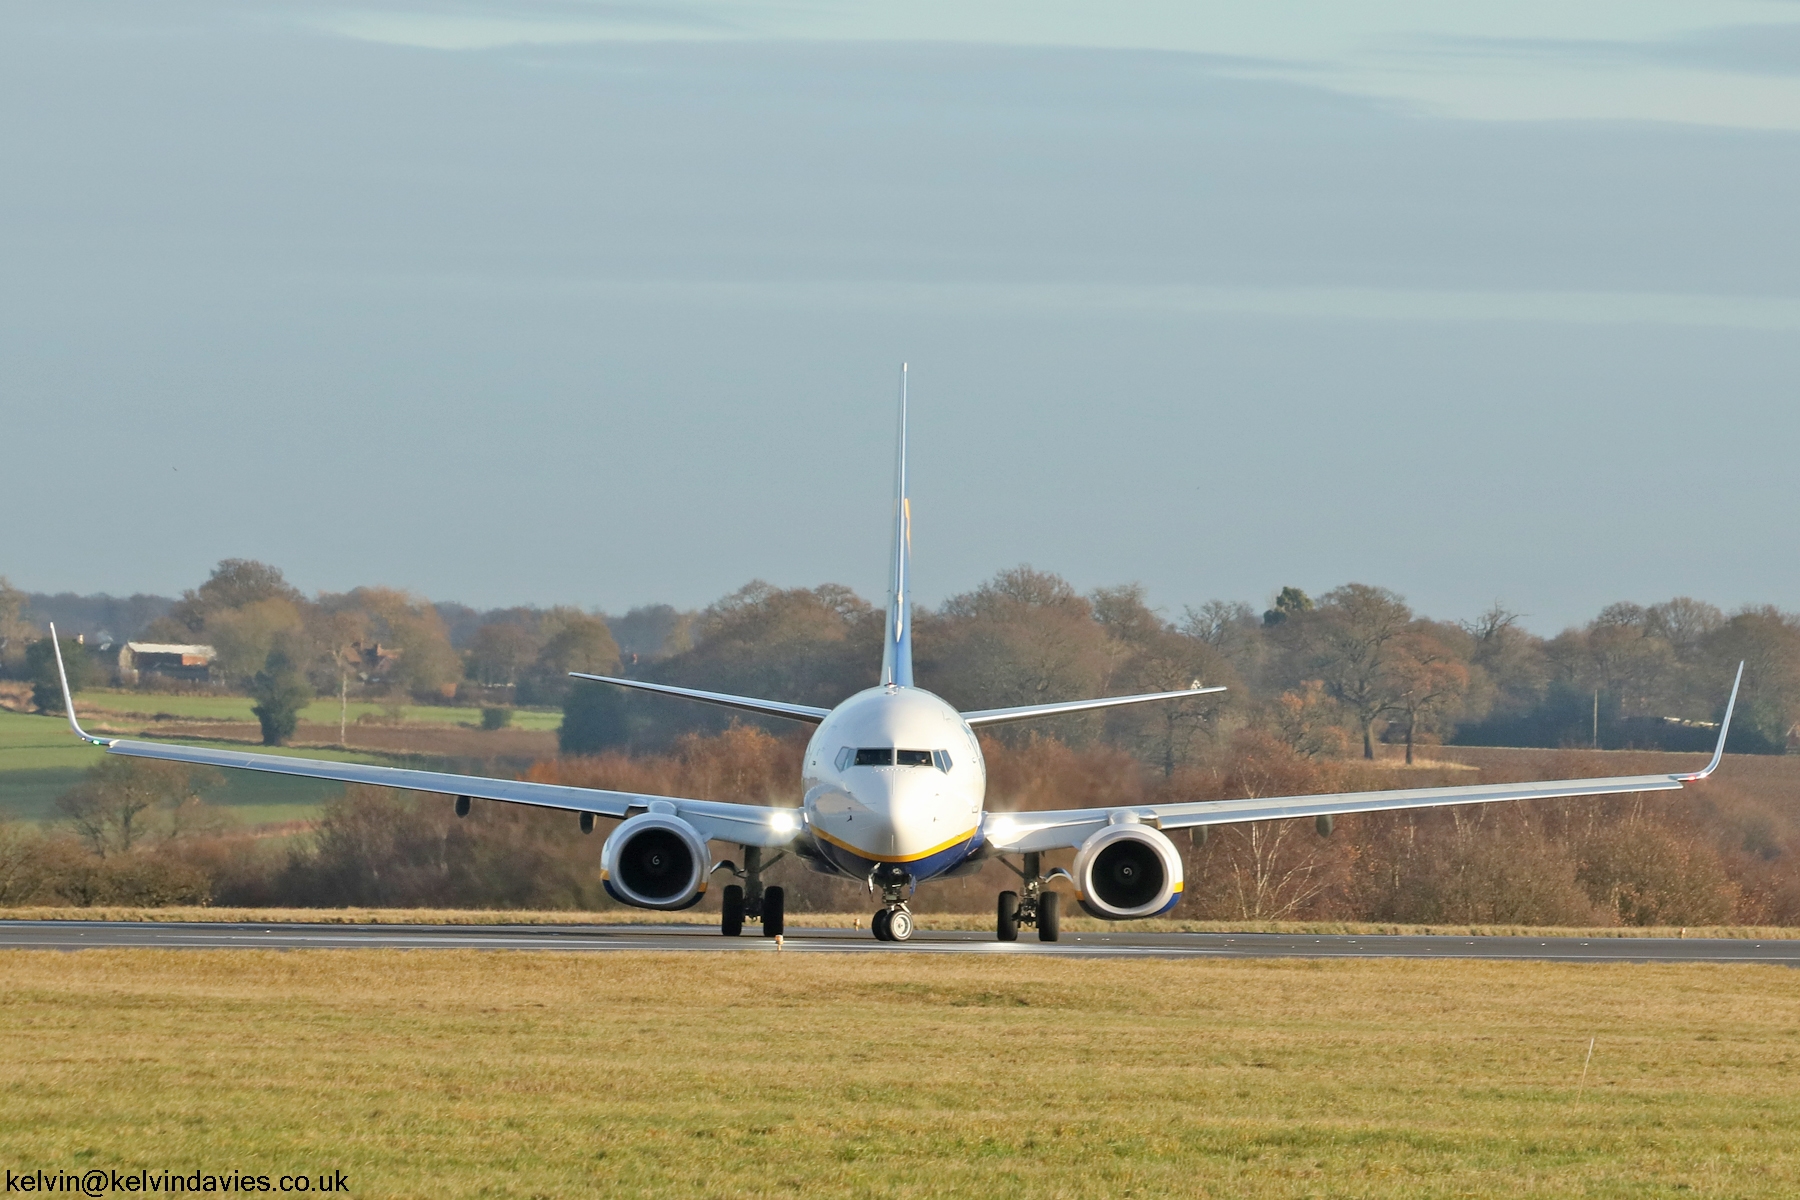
[0,560,1800,759]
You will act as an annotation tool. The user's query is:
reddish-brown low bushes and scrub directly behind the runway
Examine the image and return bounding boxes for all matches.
[0,725,1800,927]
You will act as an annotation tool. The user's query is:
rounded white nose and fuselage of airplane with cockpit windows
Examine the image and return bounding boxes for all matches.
[803,685,988,882]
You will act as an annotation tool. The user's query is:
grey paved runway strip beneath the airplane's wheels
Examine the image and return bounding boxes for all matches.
[0,921,1800,966]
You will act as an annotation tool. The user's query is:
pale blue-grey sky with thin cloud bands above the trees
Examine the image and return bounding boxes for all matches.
[0,0,1800,633]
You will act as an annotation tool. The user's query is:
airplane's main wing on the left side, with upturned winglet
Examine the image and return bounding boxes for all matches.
[50,628,801,847]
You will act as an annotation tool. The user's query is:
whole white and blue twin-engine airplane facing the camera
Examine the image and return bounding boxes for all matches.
[50,365,1744,943]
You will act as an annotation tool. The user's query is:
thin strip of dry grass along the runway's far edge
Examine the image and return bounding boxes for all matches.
[0,900,1800,941]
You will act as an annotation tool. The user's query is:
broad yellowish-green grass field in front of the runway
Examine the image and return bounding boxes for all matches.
[0,950,1800,1198]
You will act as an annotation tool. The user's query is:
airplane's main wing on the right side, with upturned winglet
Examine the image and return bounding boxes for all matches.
[983,664,1744,855]
